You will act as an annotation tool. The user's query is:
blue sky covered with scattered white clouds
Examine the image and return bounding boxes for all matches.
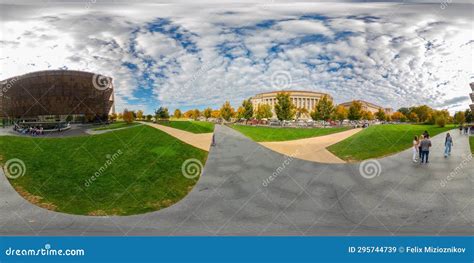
[0,0,474,113]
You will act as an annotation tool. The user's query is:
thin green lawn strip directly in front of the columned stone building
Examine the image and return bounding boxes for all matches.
[232,125,349,142]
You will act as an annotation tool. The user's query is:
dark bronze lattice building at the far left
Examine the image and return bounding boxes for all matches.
[0,70,115,122]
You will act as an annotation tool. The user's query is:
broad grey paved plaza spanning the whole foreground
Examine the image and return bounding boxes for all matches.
[0,125,474,236]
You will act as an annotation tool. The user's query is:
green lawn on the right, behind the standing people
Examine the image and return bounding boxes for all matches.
[328,124,454,161]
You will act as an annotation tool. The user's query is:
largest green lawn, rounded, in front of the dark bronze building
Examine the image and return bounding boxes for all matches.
[0,125,207,215]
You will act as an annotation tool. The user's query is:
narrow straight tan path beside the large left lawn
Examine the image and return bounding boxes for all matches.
[142,122,212,152]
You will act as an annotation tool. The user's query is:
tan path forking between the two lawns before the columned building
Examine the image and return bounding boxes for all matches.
[260,129,362,163]
